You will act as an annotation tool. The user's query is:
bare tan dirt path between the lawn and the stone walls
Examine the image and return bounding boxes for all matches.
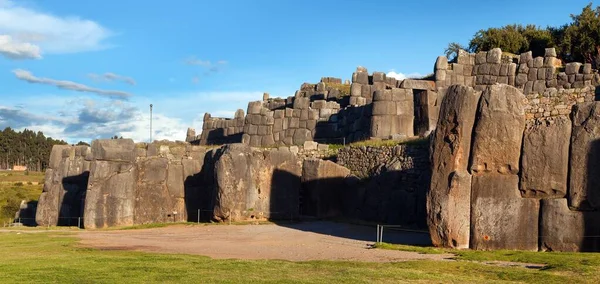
[78,222,452,262]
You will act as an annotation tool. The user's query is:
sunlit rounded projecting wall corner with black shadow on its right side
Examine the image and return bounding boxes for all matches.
[213,144,302,221]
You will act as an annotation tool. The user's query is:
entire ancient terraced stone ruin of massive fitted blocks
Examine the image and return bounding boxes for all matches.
[36,49,600,251]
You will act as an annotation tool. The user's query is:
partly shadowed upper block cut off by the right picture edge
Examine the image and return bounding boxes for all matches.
[569,102,600,210]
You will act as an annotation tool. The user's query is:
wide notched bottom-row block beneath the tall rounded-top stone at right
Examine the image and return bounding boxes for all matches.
[470,173,539,251]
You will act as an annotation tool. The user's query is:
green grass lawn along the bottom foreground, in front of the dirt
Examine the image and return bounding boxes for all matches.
[0,231,600,283]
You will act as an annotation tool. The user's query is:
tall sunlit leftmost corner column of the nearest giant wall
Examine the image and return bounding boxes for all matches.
[427,85,481,248]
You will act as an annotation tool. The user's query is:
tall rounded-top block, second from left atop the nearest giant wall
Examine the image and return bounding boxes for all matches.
[471,85,526,174]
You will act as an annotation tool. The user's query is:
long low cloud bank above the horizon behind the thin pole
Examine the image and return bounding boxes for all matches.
[0,90,262,143]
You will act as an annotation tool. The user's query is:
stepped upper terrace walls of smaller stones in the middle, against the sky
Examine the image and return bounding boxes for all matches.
[193,67,439,147]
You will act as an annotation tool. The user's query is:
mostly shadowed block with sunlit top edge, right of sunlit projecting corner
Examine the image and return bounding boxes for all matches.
[301,159,350,218]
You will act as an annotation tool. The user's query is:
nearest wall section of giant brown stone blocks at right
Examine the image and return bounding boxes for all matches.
[427,85,600,251]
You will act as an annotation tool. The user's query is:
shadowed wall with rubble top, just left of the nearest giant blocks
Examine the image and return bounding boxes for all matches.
[337,141,431,228]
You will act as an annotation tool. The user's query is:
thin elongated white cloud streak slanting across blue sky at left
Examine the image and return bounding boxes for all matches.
[13,69,131,99]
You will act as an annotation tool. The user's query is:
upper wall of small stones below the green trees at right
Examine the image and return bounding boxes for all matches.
[434,48,600,119]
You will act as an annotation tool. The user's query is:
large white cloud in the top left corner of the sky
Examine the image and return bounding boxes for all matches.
[0,0,112,53]
